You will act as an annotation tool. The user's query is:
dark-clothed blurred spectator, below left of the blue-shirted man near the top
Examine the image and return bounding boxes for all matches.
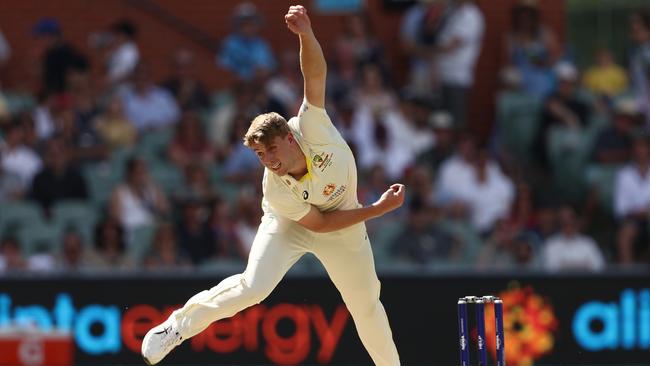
[162,48,210,111]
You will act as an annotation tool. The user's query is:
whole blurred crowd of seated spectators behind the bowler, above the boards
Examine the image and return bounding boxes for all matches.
[0,0,650,273]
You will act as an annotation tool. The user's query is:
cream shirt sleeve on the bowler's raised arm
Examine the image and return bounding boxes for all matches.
[289,99,343,145]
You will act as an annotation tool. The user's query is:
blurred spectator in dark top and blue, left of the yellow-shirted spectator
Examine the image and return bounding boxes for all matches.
[505,0,562,98]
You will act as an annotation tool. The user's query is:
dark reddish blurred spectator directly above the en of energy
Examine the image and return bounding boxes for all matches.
[144,223,192,270]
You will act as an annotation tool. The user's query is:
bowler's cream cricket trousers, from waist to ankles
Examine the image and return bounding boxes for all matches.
[174,216,400,366]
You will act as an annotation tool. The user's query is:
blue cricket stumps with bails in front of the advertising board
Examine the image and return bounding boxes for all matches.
[458,296,505,366]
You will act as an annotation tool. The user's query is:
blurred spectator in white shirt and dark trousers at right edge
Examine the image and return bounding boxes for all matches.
[614,136,650,264]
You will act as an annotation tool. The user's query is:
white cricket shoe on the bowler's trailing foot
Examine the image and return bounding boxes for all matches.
[142,314,183,365]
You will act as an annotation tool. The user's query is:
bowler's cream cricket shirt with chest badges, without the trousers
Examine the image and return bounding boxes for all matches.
[262,100,360,221]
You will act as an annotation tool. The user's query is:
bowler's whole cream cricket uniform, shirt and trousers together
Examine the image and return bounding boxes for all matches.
[174,101,400,366]
